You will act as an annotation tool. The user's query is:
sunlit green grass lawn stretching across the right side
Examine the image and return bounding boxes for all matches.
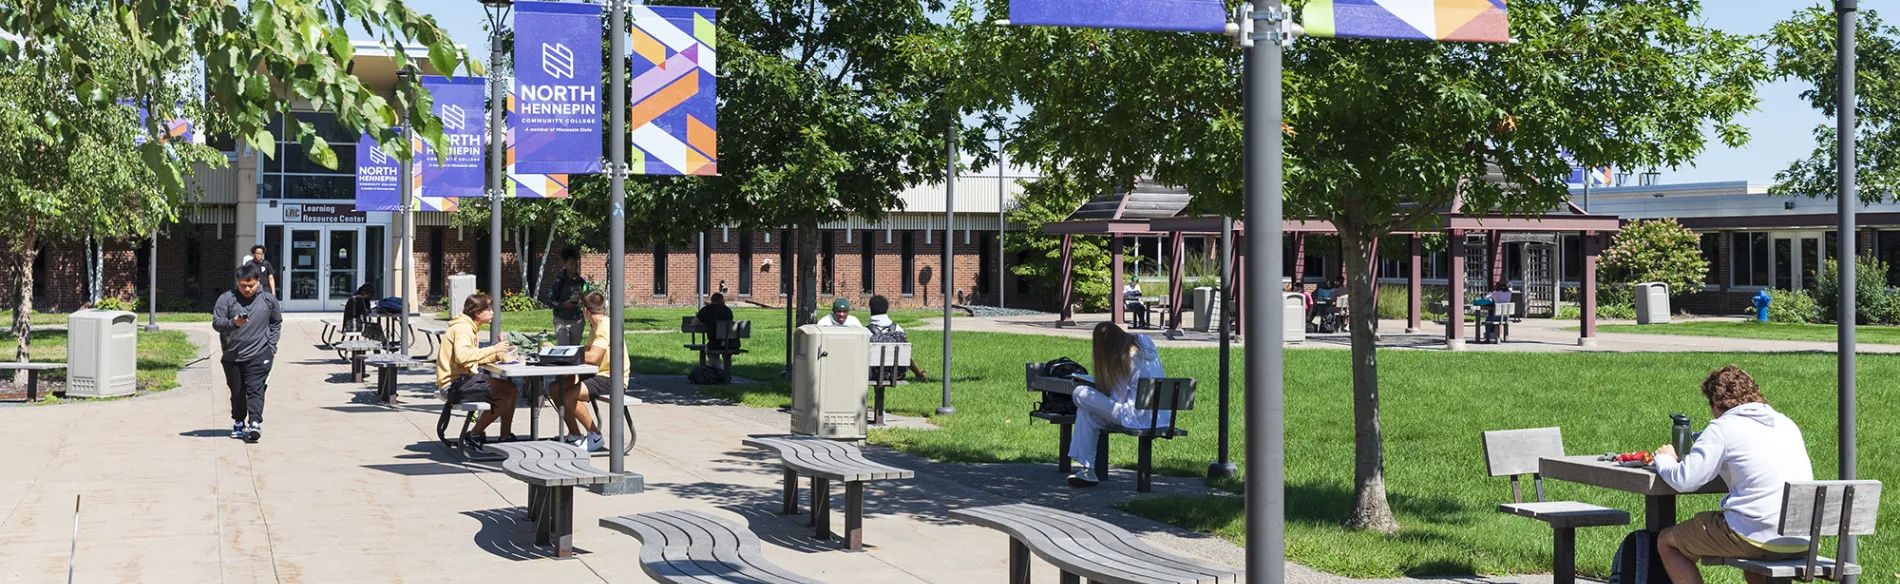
[629,325,1900,582]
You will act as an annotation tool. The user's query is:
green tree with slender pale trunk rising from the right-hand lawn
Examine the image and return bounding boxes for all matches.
[952,0,1767,533]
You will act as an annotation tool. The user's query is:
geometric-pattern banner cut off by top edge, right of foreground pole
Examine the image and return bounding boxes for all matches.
[1302,0,1511,42]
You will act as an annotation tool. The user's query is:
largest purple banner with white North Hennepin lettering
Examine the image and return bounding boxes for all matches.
[515,2,602,175]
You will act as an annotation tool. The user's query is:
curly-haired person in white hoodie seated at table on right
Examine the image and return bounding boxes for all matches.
[1655,365,1815,584]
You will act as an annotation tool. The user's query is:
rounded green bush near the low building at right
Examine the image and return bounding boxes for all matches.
[1596,219,1708,295]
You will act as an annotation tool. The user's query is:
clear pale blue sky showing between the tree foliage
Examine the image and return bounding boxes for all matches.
[397,0,1900,183]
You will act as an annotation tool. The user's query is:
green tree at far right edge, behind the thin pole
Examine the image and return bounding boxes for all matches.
[1769,6,1900,202]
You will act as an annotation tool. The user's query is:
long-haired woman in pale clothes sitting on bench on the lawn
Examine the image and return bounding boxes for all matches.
[1068,323,1169,487]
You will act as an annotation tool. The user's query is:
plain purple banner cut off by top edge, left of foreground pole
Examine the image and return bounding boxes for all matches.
[1009,0,1227,34]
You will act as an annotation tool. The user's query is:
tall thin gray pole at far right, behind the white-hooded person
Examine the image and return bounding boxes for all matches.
[1834,0,1860,574]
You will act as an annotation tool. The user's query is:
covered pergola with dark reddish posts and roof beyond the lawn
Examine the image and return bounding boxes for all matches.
[1043,188,1621,350]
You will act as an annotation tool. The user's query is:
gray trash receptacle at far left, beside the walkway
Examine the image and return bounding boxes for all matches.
[67,310,139,398]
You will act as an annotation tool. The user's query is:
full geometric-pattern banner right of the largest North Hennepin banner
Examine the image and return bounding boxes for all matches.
[627,6,718,177]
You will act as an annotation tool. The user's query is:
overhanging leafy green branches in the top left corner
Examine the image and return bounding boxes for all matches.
[0,0,477,194]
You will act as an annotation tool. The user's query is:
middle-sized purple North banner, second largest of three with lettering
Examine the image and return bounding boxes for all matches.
[416,76,488,198]
